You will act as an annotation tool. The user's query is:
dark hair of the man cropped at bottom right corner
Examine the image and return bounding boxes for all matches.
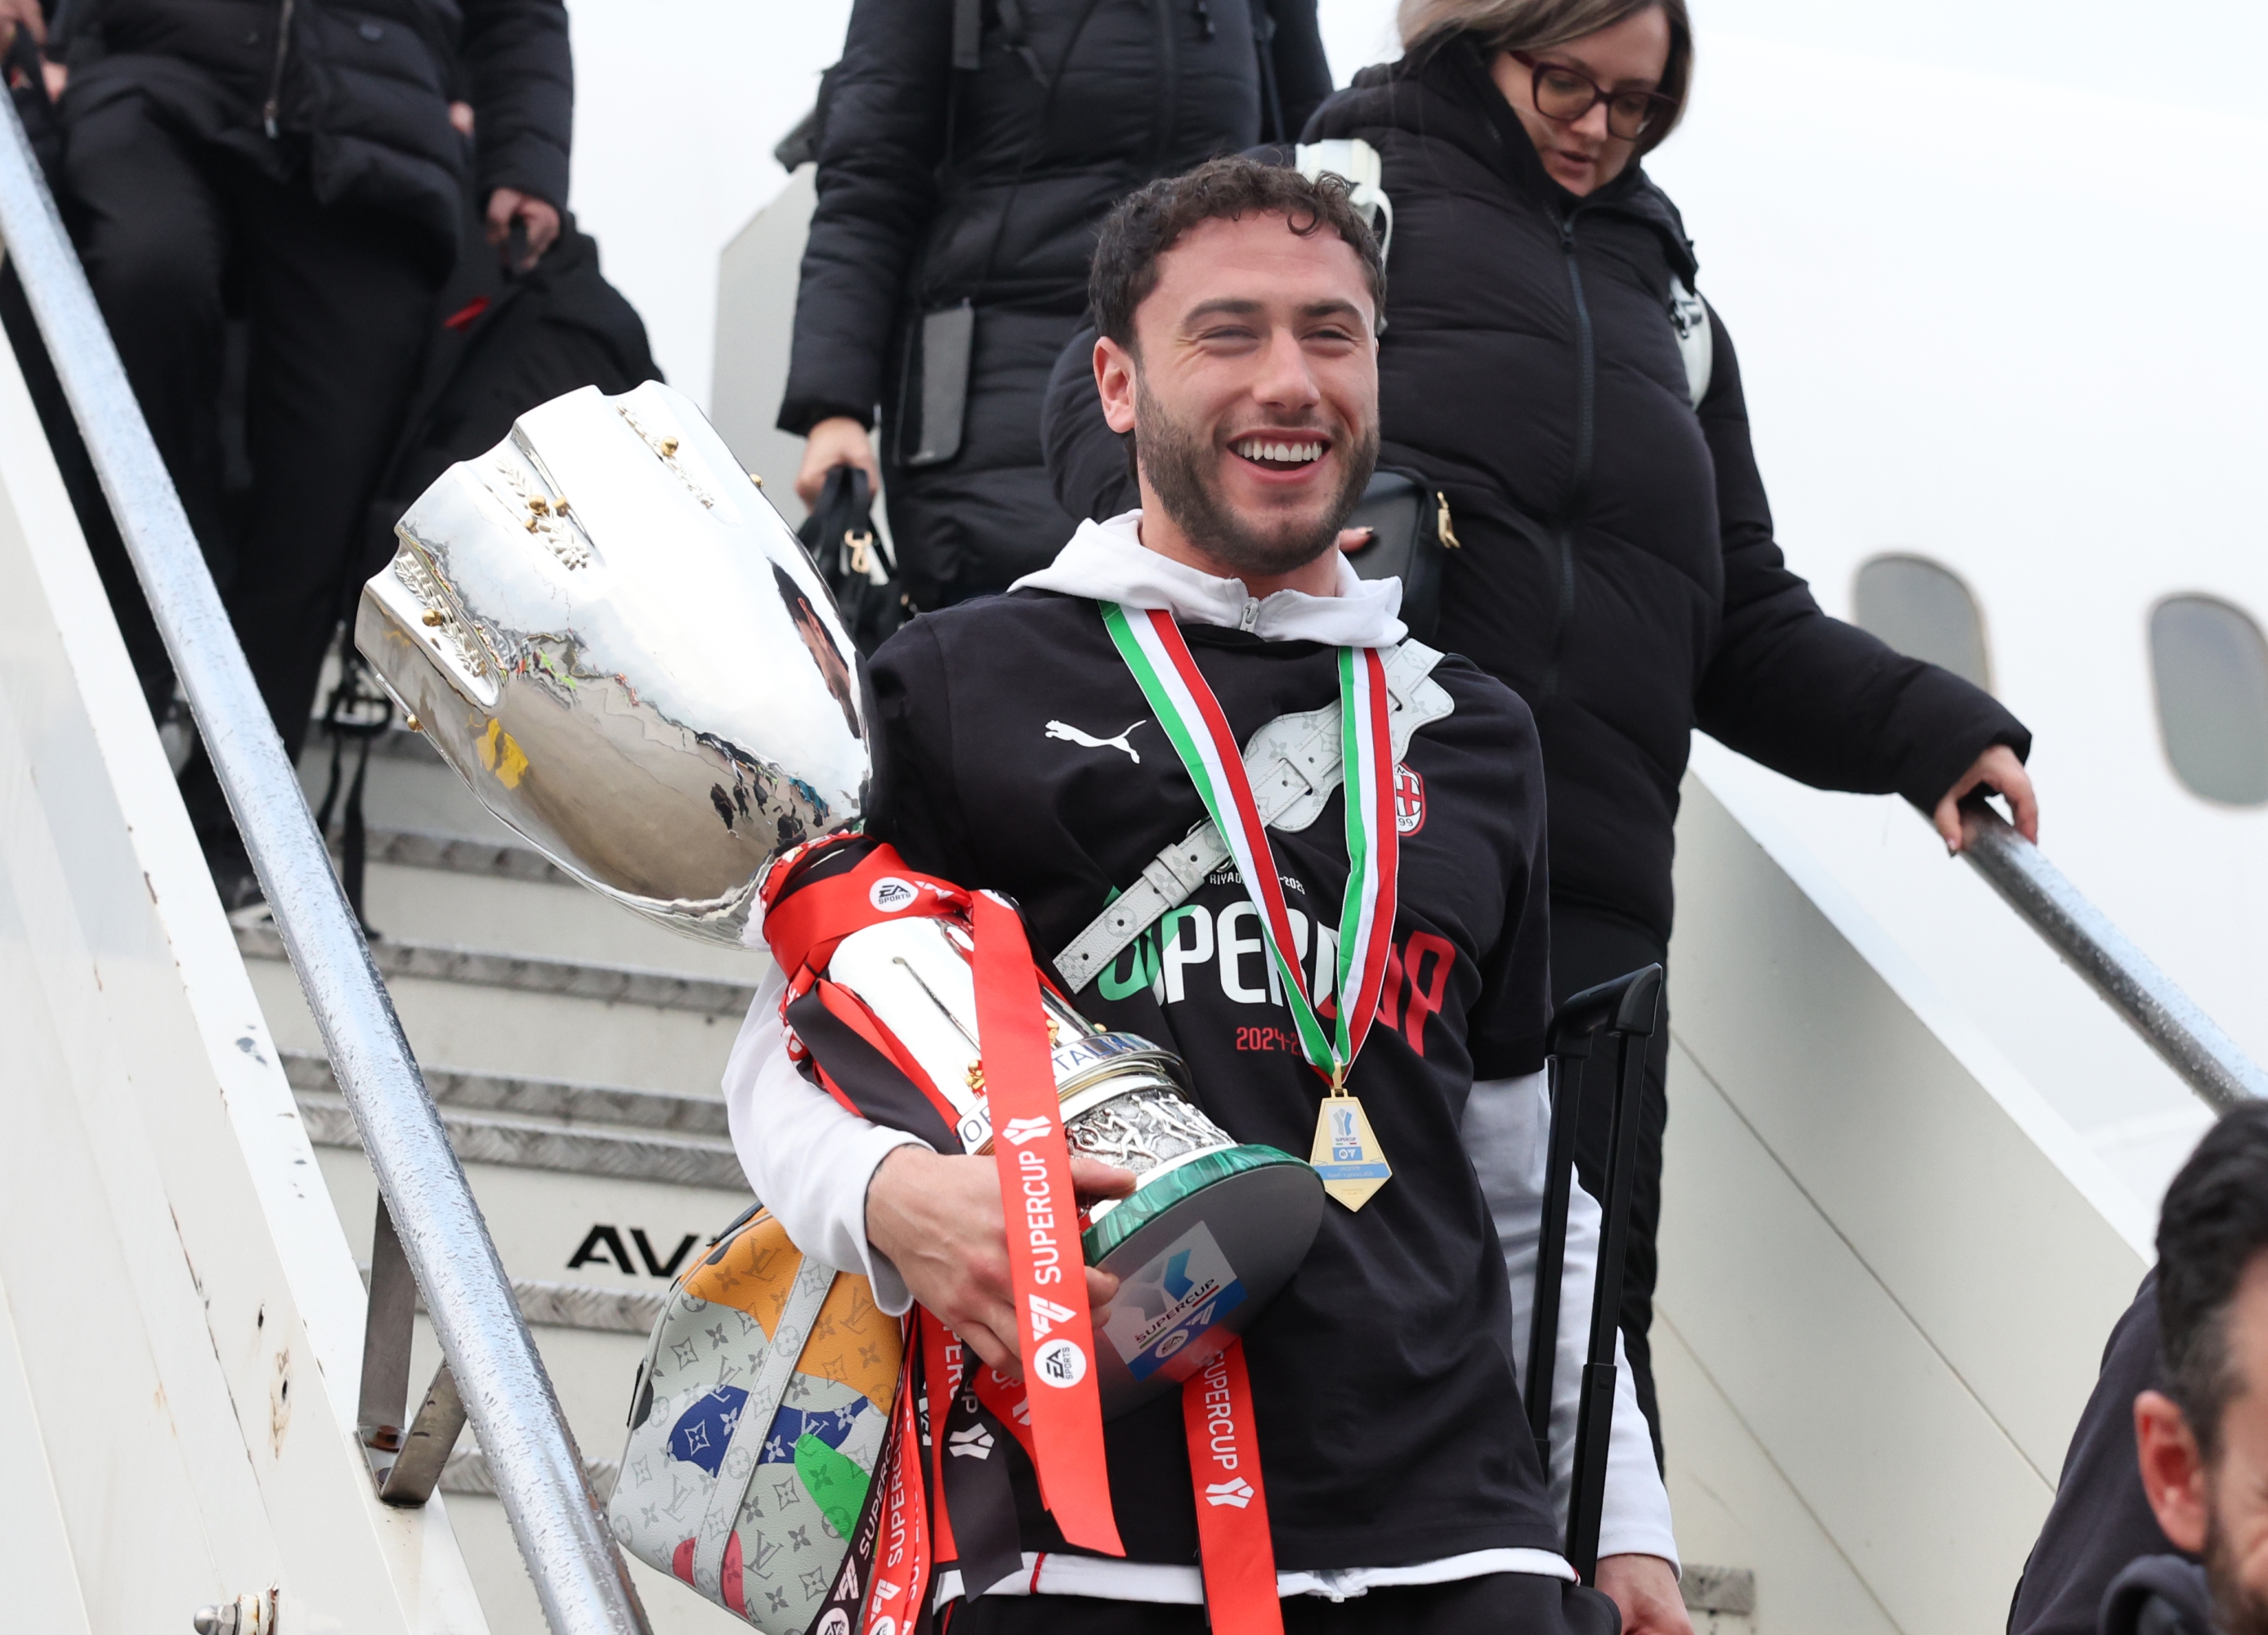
[2157,1102,2268,1460]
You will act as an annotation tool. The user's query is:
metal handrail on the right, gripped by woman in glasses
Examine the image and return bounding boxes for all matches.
[1962,803,2268,1113]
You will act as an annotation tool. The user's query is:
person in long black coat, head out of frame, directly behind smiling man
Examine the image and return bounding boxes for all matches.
[781,0,1331,607]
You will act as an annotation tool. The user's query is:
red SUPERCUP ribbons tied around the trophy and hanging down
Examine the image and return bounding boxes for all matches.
[764,837,1284,1635]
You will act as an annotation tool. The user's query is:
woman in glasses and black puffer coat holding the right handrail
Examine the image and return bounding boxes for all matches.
[1045,0,2037,1447]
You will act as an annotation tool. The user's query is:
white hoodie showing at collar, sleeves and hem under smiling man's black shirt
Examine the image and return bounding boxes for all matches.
[723,510,1679,1606]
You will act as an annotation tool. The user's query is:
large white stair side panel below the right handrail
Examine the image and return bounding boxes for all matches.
[1660,777,2148,1635]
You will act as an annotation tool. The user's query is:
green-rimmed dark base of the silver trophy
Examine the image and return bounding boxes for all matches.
[1080,1145,1322,1419]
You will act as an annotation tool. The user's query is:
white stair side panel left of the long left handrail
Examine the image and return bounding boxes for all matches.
[0,315,483,1633]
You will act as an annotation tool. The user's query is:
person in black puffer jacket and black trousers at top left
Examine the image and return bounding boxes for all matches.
[20,0,574,909]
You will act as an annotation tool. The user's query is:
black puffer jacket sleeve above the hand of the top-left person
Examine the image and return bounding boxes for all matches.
[459,0,574,211]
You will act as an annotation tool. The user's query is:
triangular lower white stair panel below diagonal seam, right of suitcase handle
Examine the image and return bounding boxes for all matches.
[1653,1313,1899,1635]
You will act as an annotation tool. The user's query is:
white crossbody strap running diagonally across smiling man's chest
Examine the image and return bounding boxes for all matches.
[1054,642,1456,993]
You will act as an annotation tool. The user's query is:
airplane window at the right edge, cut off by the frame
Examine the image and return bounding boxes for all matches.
[2150,597,2268,805]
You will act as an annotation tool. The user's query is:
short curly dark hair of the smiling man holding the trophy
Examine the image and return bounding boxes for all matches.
[1086,156,1386,352]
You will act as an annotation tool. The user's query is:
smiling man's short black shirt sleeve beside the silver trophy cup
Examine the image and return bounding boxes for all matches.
[866,619,973,885]
